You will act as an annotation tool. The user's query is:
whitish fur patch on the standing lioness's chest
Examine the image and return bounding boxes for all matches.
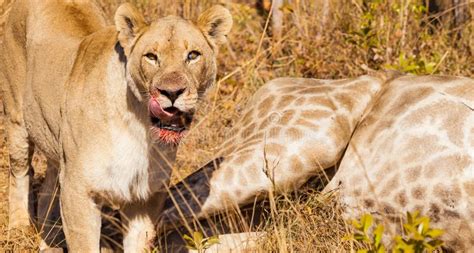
[89,118,150,202]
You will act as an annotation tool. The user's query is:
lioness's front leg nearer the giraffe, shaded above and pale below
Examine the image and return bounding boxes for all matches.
[121,193,166,252]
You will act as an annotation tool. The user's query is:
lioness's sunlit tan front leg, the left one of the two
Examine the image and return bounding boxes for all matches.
[60,177,101,253]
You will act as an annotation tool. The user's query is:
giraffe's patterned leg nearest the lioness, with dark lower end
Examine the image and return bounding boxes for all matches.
[162,76,383,227]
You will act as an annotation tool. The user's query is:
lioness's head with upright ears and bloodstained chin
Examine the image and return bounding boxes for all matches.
[115,4,232,143]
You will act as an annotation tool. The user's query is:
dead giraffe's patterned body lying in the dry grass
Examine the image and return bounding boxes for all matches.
[162,73,474,251]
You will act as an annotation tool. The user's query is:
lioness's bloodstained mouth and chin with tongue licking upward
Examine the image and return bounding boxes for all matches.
[148,98,192,144]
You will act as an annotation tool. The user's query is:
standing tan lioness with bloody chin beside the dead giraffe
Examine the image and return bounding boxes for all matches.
[0,0,232,252]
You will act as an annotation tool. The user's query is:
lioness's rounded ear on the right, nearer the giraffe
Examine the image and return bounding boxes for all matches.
[197,5,233,47]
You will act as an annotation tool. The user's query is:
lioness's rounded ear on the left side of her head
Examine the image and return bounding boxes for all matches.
[114,3,147,48]
